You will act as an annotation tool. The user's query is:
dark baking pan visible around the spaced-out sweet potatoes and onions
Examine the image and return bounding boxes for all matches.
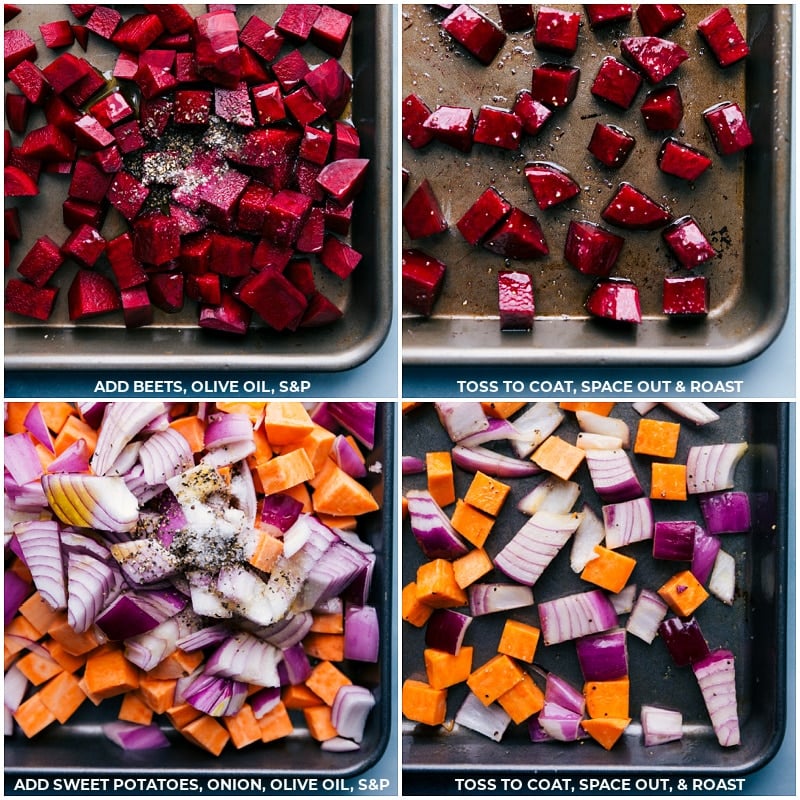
[402,403,789,775]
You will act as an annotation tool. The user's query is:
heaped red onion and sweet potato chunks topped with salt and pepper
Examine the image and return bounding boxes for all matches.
[5,402,382,755]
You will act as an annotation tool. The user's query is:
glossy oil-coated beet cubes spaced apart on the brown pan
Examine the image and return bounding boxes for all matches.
[402,4,753,331]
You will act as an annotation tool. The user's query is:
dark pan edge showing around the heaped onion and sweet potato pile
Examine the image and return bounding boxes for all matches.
[4,403,395,785]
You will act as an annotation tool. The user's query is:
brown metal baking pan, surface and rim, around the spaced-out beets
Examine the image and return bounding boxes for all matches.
[402,5,792,365]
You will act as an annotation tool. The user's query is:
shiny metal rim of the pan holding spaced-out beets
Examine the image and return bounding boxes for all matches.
[402,6,794,366]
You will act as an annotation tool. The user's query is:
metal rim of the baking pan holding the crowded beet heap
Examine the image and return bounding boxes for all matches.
[4,5,395,372]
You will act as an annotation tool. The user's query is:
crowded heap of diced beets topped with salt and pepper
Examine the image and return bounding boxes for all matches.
[4,3,369,334]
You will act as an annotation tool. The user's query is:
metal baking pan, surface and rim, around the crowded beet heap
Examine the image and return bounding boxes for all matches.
[5,5,393,371]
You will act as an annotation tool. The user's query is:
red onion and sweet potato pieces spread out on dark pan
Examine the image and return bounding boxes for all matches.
[403,402,757,749]
